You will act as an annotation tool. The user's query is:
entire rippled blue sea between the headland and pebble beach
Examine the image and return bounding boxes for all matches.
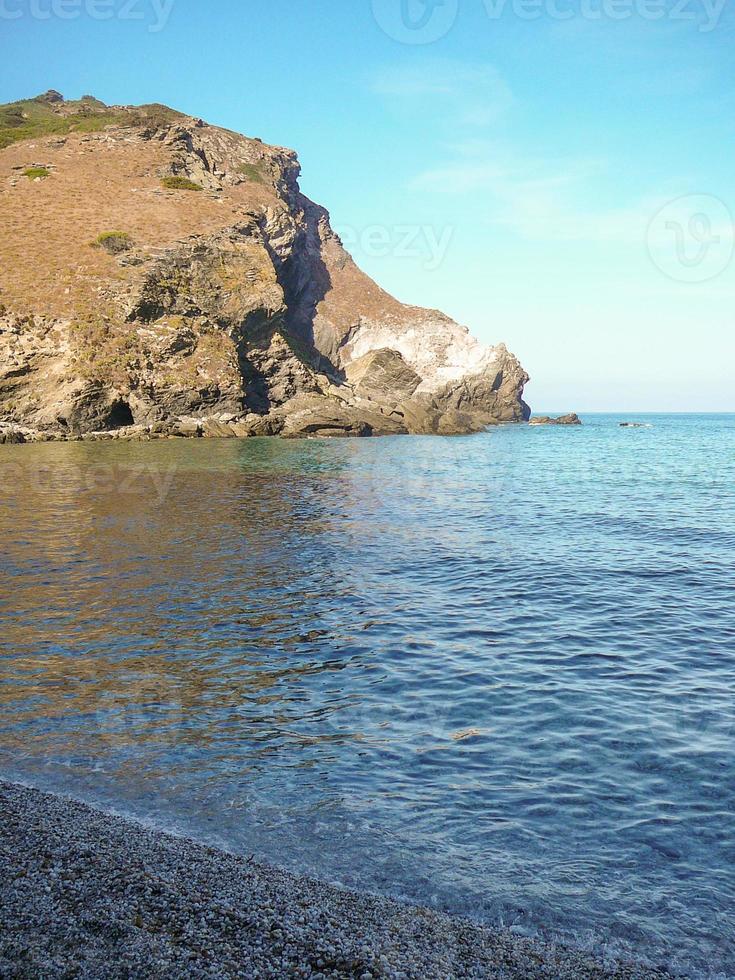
[0,416,735,976]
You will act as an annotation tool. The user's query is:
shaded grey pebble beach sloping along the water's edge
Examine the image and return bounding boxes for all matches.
[0,782,669,980]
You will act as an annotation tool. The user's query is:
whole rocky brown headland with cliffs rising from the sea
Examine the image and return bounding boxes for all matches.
[0,93,529,437]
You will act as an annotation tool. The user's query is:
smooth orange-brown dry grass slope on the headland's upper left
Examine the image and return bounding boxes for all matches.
[0,121,273,317]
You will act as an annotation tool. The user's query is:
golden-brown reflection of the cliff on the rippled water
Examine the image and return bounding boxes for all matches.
[0,440,374,773]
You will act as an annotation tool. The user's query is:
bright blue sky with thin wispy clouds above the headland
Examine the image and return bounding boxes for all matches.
[0,0,735,412]
